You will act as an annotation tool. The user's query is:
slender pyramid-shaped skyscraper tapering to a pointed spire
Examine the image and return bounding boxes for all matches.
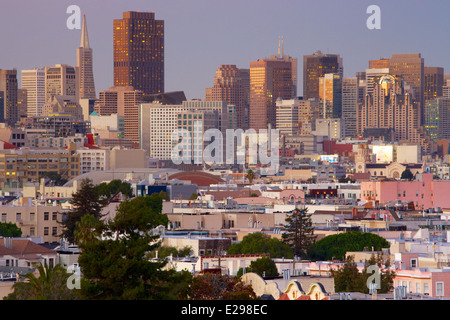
[77,15,96,99]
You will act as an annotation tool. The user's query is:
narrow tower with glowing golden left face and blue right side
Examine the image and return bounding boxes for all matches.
[319,73,342,118]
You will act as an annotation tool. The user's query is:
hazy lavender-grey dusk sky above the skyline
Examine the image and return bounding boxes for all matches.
[0,0,450,99]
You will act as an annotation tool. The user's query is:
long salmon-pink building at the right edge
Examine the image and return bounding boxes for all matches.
[361,173,450,210]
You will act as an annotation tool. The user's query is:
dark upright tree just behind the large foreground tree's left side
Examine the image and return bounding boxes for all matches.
[61,179,107,243]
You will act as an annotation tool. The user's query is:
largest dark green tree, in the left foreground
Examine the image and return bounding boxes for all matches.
[77,194,191,300]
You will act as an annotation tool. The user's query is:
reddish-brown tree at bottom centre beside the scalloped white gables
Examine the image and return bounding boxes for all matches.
[189,273,257,300]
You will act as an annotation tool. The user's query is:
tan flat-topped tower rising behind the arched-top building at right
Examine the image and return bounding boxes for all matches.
[389,53,425,125]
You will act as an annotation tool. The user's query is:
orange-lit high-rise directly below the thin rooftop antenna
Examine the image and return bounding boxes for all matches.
[249,59,295,130]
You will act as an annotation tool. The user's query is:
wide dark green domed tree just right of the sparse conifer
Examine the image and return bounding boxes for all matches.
[308,231,389,260]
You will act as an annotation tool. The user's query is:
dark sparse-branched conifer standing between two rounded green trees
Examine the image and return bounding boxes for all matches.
[282,208,316,258]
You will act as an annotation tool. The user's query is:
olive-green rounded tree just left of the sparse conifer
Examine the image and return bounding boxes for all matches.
[227,232,293,259]
